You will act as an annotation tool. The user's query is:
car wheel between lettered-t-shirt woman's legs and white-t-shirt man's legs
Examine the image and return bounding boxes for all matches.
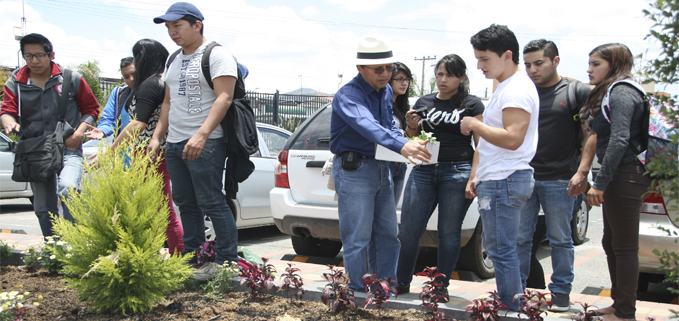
[457,220,495,279]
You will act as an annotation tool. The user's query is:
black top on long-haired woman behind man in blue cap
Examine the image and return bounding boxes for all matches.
[126,75,167,149]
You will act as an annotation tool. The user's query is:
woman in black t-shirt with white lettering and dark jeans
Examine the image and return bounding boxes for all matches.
[397,54,484,298]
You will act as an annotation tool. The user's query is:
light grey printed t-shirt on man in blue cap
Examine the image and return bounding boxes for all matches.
[162,42,238,143]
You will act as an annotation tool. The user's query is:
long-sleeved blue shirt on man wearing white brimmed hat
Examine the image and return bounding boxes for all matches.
[330,73,408,157]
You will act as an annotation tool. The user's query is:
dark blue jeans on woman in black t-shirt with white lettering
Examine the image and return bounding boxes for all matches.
[398,162,472,286]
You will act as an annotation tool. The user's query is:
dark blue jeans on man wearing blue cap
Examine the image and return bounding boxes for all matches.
[165,138,238,264]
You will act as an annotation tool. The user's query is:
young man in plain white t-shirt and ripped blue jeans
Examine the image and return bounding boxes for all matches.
[461,24,540,311]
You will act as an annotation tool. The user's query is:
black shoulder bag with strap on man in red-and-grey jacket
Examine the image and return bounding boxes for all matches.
[12,69,72,182]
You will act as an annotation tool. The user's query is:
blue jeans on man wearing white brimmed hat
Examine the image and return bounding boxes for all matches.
[332,156,400,292]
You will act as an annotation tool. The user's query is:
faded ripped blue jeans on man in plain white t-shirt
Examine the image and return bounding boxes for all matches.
[476,170,534,311]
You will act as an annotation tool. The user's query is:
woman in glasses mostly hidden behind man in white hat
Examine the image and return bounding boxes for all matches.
[389,62,413,205]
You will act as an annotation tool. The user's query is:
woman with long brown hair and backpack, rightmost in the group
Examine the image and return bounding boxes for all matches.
[580,43,651,321]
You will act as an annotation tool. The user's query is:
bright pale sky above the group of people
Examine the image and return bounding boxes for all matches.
[0,0,677,96]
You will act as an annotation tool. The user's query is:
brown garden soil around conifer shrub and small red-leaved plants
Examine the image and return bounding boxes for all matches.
[0,266,425,321]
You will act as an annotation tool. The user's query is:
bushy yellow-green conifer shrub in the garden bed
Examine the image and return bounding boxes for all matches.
[54,135,193,313]
